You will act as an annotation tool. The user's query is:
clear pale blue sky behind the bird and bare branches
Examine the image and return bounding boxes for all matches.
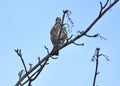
[0,0,120,86]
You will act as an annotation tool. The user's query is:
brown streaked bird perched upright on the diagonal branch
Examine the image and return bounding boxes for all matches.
[50,17,67,55]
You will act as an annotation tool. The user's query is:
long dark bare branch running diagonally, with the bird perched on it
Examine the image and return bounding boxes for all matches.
[15,0,119,86]
